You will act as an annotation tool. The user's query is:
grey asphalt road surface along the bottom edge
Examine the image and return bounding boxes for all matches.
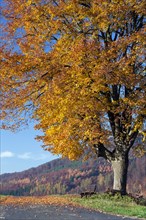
[0,205,142,220]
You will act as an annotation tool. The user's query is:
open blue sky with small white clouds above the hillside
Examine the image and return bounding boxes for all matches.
[0,124,57,174]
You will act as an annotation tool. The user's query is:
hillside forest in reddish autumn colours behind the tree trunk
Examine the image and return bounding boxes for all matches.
[0,156,146,196]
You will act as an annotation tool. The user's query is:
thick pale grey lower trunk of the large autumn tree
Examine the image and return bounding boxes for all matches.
[111,154,129,195]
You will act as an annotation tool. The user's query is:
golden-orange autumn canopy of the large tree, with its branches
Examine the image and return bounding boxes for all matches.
[0,0,146,160]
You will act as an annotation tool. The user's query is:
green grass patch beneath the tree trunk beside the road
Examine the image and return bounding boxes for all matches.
[71,194,146,219]
